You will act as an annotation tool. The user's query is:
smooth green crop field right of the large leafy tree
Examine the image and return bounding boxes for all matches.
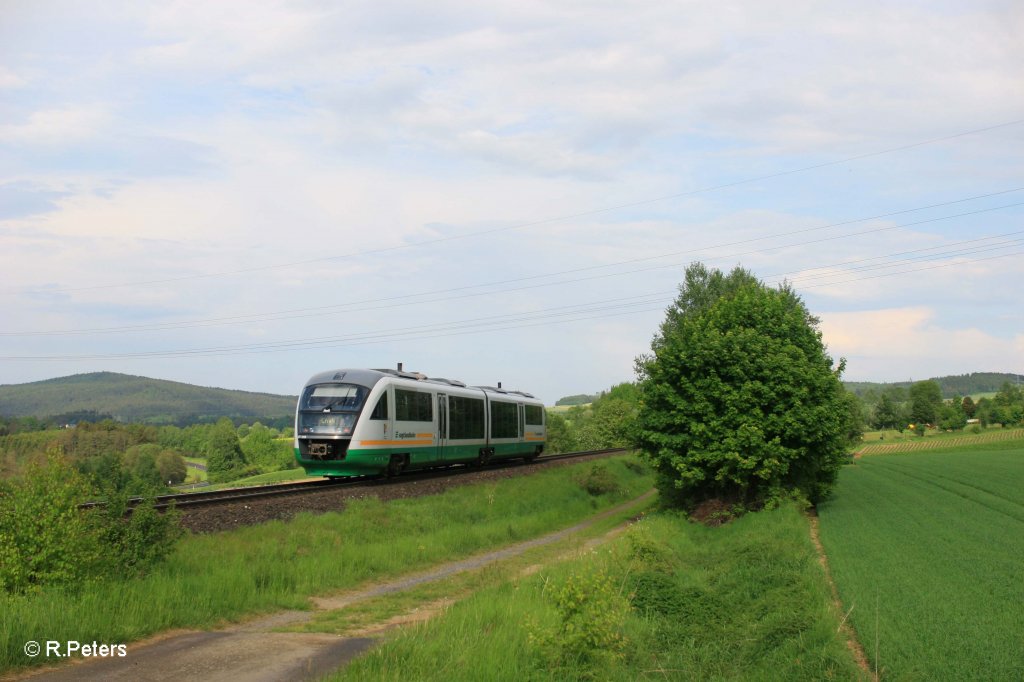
[818,440,1024,680]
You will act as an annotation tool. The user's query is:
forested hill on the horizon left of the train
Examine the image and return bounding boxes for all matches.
[0,372,296,424]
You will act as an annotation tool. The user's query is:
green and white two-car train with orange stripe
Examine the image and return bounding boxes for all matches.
[295,365,545,477]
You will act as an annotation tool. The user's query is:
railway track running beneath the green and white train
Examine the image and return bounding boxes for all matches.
[79,447,628,509]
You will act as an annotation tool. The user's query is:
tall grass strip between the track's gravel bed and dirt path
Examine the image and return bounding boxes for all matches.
[0,457,651,670]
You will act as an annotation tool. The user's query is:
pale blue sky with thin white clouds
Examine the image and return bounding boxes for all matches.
[0,0,1024,404]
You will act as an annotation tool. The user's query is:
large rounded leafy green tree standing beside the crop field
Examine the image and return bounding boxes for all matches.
[635,264,850,507]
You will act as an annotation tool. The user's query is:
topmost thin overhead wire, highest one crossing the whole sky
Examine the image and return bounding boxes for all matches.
[9,119,1024,295]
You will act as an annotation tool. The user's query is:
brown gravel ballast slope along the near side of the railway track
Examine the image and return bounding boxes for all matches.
[179,449,626,532]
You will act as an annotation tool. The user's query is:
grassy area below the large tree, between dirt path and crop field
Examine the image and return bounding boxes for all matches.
[335,507,864,681]
